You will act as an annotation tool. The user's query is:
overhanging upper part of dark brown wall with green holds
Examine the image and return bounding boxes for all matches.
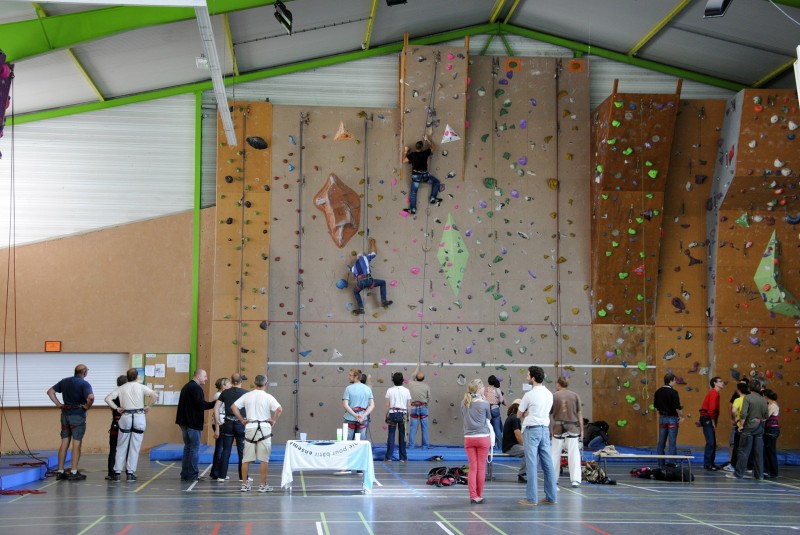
[592,89,678,325]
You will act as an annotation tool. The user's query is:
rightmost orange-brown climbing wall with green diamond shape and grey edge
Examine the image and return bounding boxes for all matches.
[709,90,800,447]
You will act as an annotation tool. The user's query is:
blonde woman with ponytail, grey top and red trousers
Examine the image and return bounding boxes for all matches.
[461,379,492,503]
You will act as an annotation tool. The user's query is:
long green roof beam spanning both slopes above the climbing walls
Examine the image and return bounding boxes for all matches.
[7,23,747,125]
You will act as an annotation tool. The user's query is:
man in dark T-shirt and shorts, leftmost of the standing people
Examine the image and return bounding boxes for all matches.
[47,364,94,481]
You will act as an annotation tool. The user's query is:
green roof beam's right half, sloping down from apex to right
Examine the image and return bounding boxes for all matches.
[501,24,747,91]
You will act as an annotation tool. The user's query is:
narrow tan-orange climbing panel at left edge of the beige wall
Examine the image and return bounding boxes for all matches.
[208,102,272,381]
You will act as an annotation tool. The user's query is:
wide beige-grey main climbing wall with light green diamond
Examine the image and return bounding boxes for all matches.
[270,58,591,443]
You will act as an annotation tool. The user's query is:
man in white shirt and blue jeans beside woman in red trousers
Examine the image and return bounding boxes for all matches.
[517,366,557,507]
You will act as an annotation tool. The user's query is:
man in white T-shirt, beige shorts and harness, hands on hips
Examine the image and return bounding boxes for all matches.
[231,375,283,492]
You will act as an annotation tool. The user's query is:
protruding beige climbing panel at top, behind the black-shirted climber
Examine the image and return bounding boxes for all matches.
[398,45,469,181]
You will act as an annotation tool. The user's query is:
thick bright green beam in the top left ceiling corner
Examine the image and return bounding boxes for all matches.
[0,0,278,63]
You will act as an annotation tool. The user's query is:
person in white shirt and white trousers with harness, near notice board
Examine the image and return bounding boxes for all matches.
[106,368,158,481]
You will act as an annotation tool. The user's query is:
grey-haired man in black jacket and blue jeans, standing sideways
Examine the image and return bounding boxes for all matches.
[175,368,215,481]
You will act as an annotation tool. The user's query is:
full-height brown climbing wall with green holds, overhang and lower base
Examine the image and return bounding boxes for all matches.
[591,88,678,444]
